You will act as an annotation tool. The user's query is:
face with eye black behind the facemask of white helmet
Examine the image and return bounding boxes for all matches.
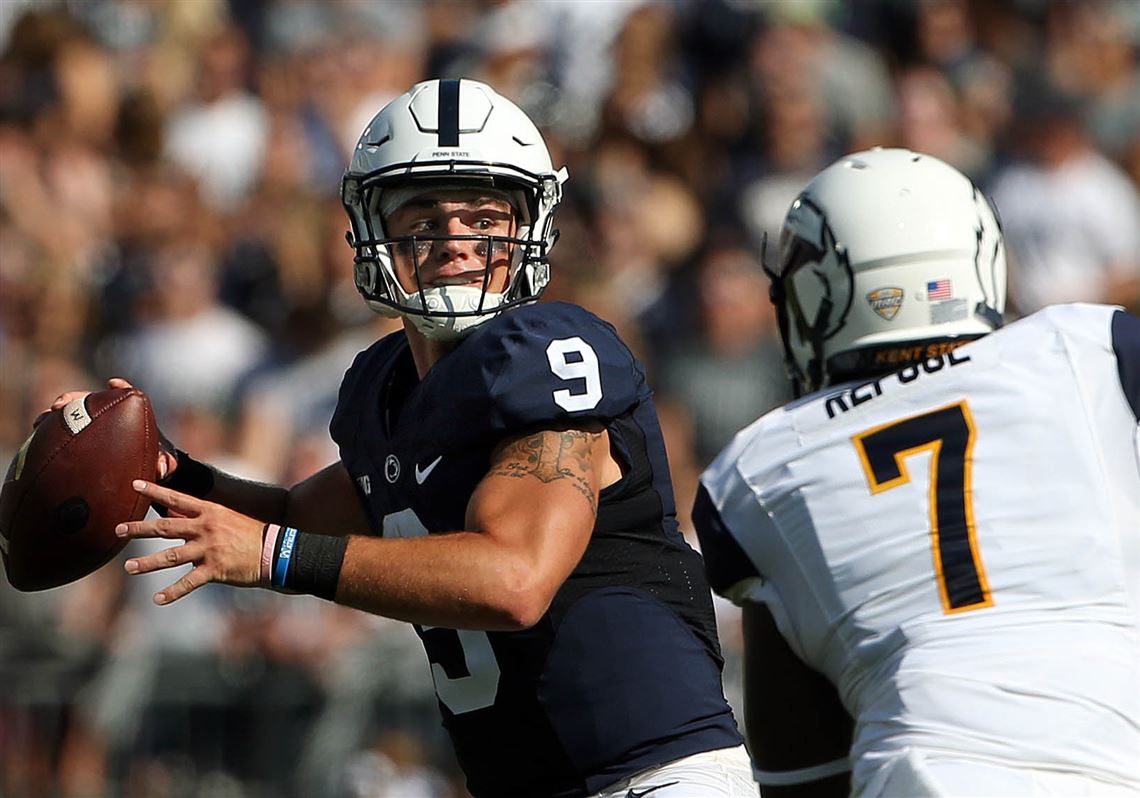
[385,189,516,294]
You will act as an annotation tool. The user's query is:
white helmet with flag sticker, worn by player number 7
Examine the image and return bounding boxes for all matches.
[765,148,1005,396]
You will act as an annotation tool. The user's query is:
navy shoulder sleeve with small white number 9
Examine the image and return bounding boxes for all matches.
[472,302,649,433]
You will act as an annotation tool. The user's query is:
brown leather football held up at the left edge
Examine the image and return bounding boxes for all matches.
[0,388,158,592]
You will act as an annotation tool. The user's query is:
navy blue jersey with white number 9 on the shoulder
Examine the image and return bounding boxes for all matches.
[332,303,741,797]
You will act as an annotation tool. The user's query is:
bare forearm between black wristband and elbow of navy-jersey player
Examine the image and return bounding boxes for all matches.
[336,532,554,630]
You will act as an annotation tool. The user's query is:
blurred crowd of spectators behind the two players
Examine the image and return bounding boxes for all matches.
[0,0,1140,798]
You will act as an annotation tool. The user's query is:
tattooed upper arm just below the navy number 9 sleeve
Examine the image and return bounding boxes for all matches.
[488,430,604,515]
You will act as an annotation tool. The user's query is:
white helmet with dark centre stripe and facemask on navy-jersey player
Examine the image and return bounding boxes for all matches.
[341,80,567,341]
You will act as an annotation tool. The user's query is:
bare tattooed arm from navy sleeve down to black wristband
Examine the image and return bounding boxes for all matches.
[336,426,620,630]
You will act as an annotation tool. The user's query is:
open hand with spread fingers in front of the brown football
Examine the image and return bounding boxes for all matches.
[115,480,264,604]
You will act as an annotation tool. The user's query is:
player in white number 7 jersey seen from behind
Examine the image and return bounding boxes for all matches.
[693,149,1140,796]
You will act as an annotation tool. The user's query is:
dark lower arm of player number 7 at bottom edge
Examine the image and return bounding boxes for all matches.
[742,602,853,798]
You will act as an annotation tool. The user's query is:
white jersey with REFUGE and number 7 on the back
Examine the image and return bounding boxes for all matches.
[699,304,1140,795]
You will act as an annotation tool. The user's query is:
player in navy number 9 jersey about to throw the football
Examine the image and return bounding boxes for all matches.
[68,80,756,798]
